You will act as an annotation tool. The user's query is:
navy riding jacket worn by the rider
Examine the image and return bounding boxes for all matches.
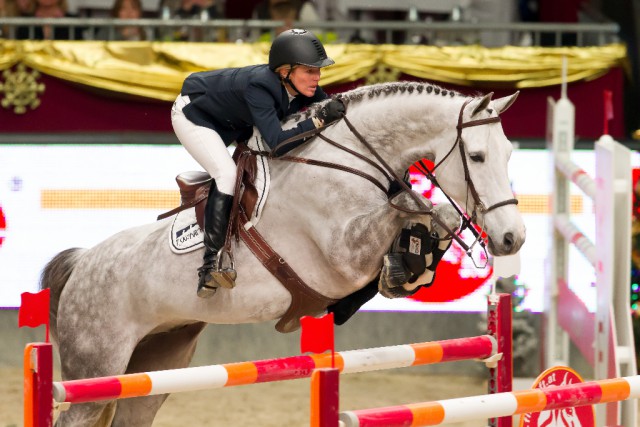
[181,65,328,148]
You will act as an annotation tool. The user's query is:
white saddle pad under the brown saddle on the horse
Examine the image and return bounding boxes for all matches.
[169,136,271,254]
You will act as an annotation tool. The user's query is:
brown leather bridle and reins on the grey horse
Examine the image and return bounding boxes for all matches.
[254,98,518,268]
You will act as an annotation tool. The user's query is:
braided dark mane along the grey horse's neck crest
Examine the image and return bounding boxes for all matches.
[285,81,464,122]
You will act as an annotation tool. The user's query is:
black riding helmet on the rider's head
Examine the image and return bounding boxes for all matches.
[269,29,335,71]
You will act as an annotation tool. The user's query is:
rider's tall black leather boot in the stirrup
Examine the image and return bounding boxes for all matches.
[198,181,237,298]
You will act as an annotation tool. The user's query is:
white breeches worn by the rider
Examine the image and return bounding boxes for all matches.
[171,95,236,195]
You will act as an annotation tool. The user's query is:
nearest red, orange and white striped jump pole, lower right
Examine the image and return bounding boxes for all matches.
[339,375,640,427]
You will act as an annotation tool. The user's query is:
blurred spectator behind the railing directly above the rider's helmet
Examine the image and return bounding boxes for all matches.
[252,0,325,42]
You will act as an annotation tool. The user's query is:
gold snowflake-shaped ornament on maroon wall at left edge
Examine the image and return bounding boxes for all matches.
[0,64,45,114]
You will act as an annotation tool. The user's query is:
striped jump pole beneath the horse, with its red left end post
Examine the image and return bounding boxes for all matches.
[25,335,498,427]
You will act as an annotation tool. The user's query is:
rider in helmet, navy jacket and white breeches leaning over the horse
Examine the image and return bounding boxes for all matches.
[171,29,344,298]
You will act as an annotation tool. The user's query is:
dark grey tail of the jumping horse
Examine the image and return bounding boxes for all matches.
[40,248,85,339]
